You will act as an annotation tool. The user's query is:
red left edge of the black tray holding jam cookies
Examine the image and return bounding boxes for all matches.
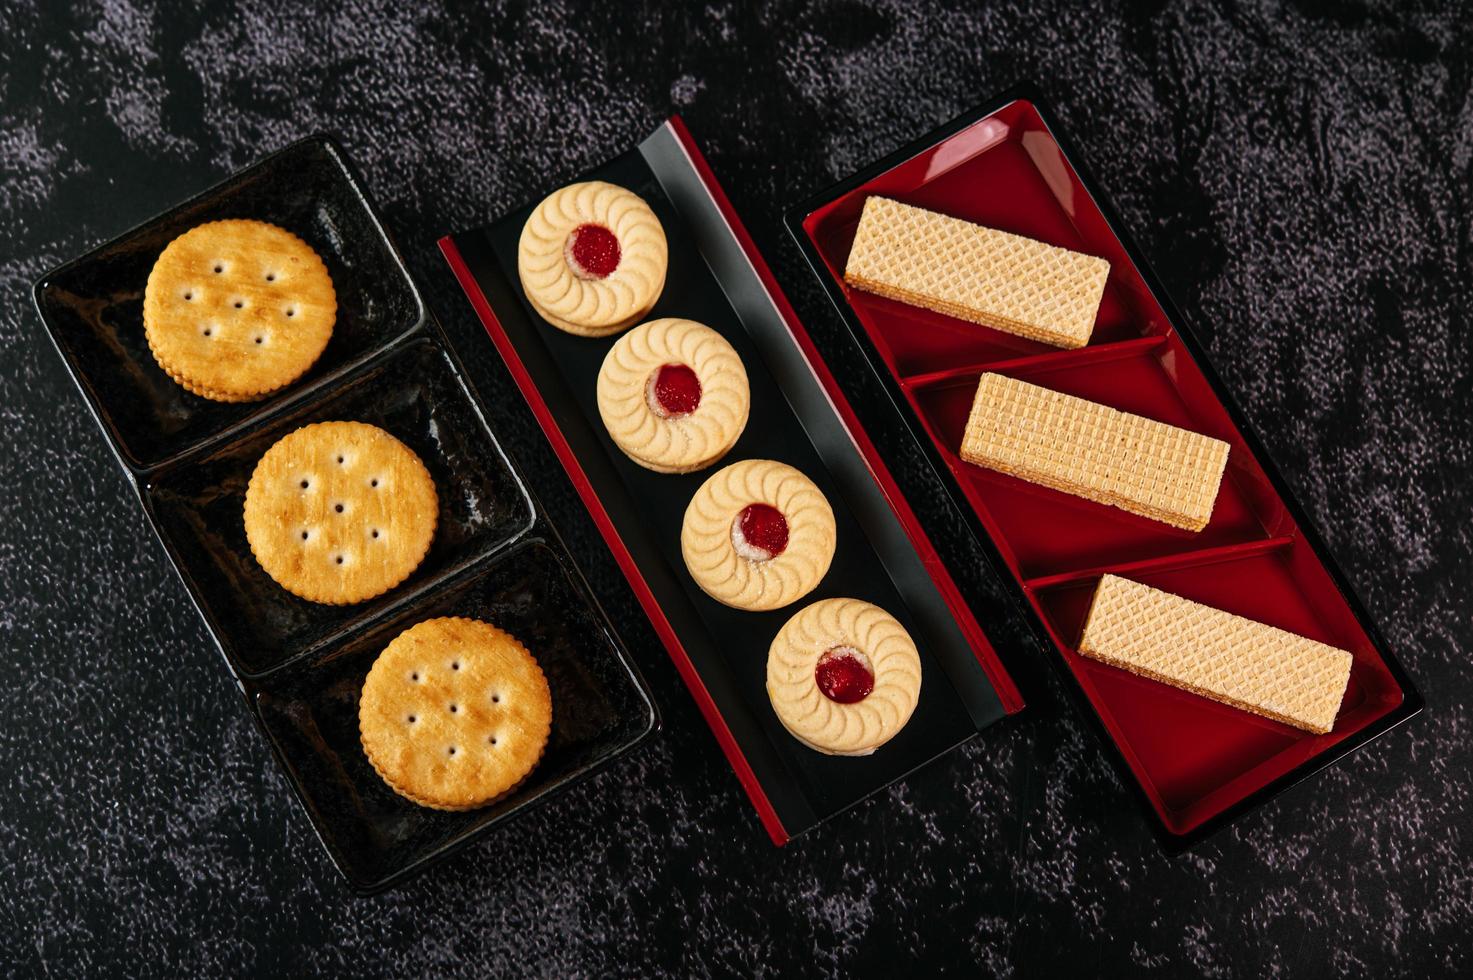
[439,236,788,847]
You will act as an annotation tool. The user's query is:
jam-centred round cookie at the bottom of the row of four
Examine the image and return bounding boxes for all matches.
[767,598,921,756]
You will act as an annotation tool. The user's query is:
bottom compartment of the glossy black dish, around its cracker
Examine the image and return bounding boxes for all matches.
[256,539,655,890]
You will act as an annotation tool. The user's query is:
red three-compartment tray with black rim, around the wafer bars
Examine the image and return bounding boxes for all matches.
[787,88,1421,847]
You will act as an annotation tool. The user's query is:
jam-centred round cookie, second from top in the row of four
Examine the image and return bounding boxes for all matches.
[598,320,751,473]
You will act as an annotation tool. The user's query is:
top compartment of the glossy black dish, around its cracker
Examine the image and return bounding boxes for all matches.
[35,136,424,470]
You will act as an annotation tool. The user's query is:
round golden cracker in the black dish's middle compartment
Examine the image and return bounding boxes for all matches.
[246,421,439,604]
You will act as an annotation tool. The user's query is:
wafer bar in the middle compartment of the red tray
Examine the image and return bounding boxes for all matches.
[962,374,1227,531]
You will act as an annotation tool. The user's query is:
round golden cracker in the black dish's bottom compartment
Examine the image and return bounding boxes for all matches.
[358,616,552,811]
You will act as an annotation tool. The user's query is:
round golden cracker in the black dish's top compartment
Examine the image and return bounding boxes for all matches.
[143,220,337,402]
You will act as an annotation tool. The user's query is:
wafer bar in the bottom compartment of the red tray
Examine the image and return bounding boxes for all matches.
[1080,575,1352,734]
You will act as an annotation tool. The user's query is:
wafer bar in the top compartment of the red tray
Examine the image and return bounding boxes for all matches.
[844,197,1109,348]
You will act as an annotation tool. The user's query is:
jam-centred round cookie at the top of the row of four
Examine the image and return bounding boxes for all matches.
[517,180,669,337]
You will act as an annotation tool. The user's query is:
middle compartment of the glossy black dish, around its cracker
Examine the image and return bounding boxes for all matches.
[143,339,533,676]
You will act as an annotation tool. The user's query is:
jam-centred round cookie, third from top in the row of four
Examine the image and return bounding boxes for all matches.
[681,460,837,610]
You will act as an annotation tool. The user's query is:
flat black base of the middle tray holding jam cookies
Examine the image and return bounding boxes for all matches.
[441,152,1005,836]
